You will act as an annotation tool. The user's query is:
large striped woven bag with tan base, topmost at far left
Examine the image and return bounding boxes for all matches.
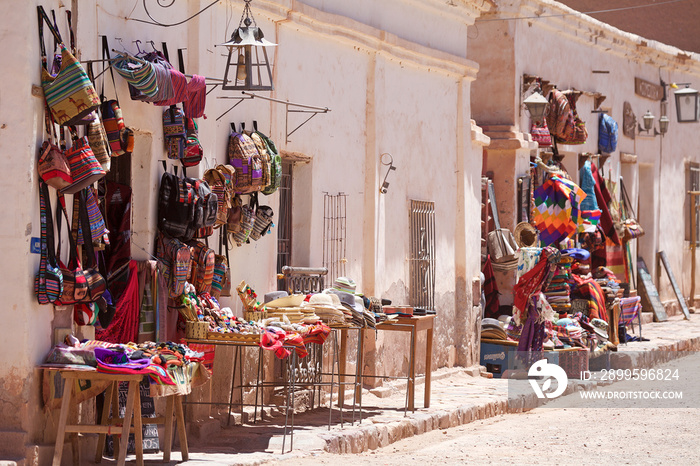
[41,44,100,125]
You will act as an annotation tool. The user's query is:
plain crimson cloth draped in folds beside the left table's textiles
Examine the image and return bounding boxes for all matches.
[95,260,139,343]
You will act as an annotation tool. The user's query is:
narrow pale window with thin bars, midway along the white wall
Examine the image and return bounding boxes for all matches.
[323,193,348,283]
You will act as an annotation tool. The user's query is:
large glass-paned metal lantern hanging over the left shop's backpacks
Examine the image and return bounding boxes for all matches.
[218,0,277,91]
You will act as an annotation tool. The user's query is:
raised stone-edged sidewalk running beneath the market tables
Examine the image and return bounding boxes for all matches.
[138,315,700,466]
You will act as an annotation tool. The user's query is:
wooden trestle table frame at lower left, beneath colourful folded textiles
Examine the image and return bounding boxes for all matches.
[52,367,189,466]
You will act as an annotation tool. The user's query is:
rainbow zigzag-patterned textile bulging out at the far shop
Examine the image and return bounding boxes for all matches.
[533,176,586,246]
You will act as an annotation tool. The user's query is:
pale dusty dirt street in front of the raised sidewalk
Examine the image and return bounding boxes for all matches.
[302,354,700,466]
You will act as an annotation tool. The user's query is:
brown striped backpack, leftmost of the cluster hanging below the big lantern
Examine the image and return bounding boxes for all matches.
[228,124,264,194]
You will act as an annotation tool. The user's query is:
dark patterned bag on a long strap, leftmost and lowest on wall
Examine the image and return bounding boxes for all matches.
[34,181,63,304]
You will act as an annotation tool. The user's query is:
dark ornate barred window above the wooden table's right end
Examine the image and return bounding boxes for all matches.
[409,200,435,310]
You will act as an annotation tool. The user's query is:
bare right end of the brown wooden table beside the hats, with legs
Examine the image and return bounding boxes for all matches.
[377,314,435,411]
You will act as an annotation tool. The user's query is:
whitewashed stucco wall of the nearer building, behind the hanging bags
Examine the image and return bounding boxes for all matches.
[0,0,488,458]
